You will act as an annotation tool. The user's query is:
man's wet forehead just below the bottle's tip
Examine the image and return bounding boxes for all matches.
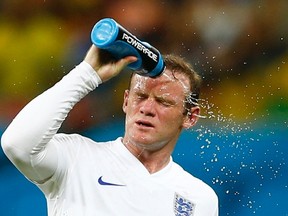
[130,69,190,94]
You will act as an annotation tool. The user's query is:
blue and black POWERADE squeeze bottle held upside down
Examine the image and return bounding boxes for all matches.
[91,18,165,77]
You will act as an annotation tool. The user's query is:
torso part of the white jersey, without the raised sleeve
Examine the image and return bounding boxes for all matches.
[39,134,217,216]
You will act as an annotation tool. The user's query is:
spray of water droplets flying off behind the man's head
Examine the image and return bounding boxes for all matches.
[184,99,287,215]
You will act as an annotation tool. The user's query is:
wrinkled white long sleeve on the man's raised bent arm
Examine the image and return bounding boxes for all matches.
[1,61,101,183]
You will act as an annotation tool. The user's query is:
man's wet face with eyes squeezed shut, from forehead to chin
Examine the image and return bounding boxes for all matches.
[123,70,199,150]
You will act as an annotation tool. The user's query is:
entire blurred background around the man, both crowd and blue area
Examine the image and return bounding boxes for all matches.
[0,0,288,216]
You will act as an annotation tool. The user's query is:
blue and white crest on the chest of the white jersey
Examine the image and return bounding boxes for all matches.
[174,193,195,216]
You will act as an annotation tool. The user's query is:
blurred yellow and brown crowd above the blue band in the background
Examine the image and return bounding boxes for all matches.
[0,0,288,131]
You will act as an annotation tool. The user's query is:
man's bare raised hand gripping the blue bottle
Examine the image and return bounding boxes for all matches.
[84,45,137,82]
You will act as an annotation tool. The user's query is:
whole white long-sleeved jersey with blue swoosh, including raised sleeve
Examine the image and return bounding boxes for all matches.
[2,62,218,216]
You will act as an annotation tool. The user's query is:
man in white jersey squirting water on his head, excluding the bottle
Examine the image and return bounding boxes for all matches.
[2,45,218,216]
